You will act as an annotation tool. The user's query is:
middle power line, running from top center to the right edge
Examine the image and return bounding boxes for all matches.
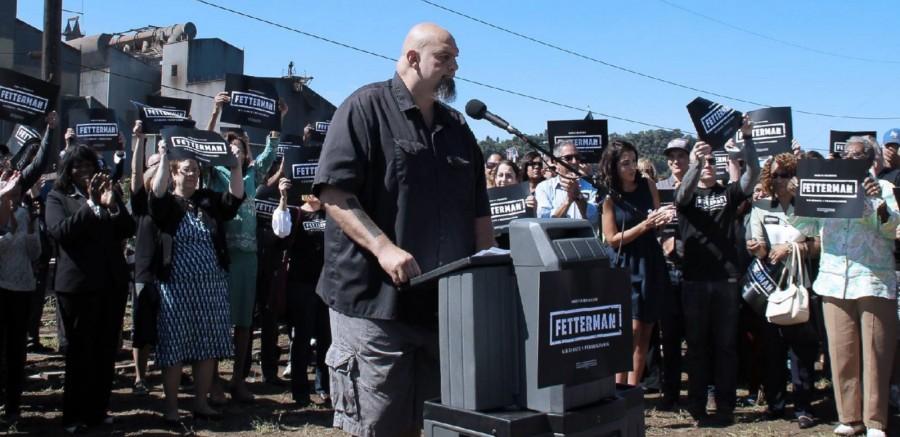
[418,0,900,120]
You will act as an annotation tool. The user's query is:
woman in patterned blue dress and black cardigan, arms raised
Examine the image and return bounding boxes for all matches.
[150,141,244,423]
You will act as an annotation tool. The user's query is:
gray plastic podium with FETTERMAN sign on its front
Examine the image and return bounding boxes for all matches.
[413,219,644,437]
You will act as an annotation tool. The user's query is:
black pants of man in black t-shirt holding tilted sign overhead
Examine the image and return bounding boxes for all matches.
[681,281,740,414]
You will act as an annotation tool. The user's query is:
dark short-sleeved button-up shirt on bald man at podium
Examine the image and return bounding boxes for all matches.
[313,74,490,321]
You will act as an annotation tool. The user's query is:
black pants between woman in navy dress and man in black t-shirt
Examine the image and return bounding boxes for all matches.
[659,284,684,402]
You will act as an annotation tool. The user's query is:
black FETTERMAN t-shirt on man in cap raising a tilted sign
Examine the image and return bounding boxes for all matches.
[678,182,750,281]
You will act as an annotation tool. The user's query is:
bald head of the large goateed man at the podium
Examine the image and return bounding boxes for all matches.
[397,23,459,101]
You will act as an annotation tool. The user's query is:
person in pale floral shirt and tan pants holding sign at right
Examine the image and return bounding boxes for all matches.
[788,136,900,436]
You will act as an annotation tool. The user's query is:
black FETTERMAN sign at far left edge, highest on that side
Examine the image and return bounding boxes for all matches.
[0,68,59,125]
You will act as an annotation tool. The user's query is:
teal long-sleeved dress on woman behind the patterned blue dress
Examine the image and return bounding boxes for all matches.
[207,137,278,328]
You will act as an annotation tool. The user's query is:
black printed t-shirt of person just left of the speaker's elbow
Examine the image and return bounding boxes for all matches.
[288,209,327,284]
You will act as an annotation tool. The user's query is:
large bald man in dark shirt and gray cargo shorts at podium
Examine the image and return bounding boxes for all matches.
[313,23,494,436]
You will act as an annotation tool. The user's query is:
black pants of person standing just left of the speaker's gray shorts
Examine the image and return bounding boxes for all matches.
[287,282,331,403]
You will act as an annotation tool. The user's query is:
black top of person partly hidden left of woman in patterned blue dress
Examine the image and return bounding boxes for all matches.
[130,185,159,284]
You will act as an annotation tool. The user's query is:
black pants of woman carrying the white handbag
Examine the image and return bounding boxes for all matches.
[759,304,819,416]
